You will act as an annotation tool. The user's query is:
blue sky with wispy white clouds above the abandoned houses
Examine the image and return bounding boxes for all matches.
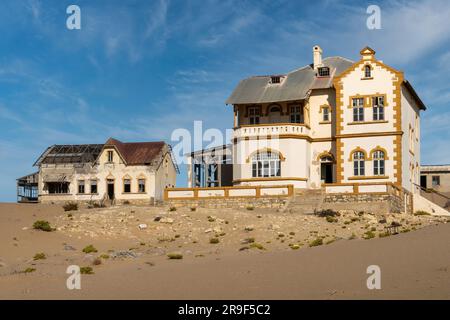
[0,0,450,201]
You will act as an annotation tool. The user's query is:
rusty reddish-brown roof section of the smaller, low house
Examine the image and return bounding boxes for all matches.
[105,138,166,165]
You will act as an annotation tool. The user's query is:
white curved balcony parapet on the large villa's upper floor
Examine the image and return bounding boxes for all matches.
[233,123,310,139]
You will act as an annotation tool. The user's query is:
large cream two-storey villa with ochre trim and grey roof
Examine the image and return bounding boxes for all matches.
[188,46,426,192]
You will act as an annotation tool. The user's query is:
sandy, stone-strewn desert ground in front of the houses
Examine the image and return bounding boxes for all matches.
[0,204,450,299]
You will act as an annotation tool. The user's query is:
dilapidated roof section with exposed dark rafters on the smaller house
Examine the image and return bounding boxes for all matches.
[33,144,103,166]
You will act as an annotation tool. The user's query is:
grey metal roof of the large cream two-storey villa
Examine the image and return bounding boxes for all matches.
[226,57,353,104]
